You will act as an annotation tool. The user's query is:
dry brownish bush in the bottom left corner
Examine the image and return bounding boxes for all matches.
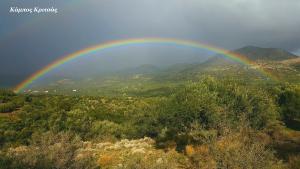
[0,132,92,169]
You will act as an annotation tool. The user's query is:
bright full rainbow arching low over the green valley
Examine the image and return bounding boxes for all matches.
[14,38,273,93]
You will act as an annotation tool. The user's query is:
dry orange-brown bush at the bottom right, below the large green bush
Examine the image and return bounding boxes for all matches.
[190,129,284,169]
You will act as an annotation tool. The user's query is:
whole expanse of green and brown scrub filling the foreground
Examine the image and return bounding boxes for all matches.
[0,77,300,169]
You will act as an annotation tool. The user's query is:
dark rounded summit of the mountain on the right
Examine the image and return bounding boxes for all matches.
[234,46,298,61]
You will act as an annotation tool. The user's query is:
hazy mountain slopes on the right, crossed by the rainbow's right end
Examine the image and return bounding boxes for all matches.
[154,46,300,81]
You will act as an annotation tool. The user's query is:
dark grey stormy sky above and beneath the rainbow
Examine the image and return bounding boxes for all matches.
[0,0,300,84]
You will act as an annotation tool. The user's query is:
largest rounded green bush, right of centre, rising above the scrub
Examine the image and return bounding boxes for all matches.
[158,78,278,148]
